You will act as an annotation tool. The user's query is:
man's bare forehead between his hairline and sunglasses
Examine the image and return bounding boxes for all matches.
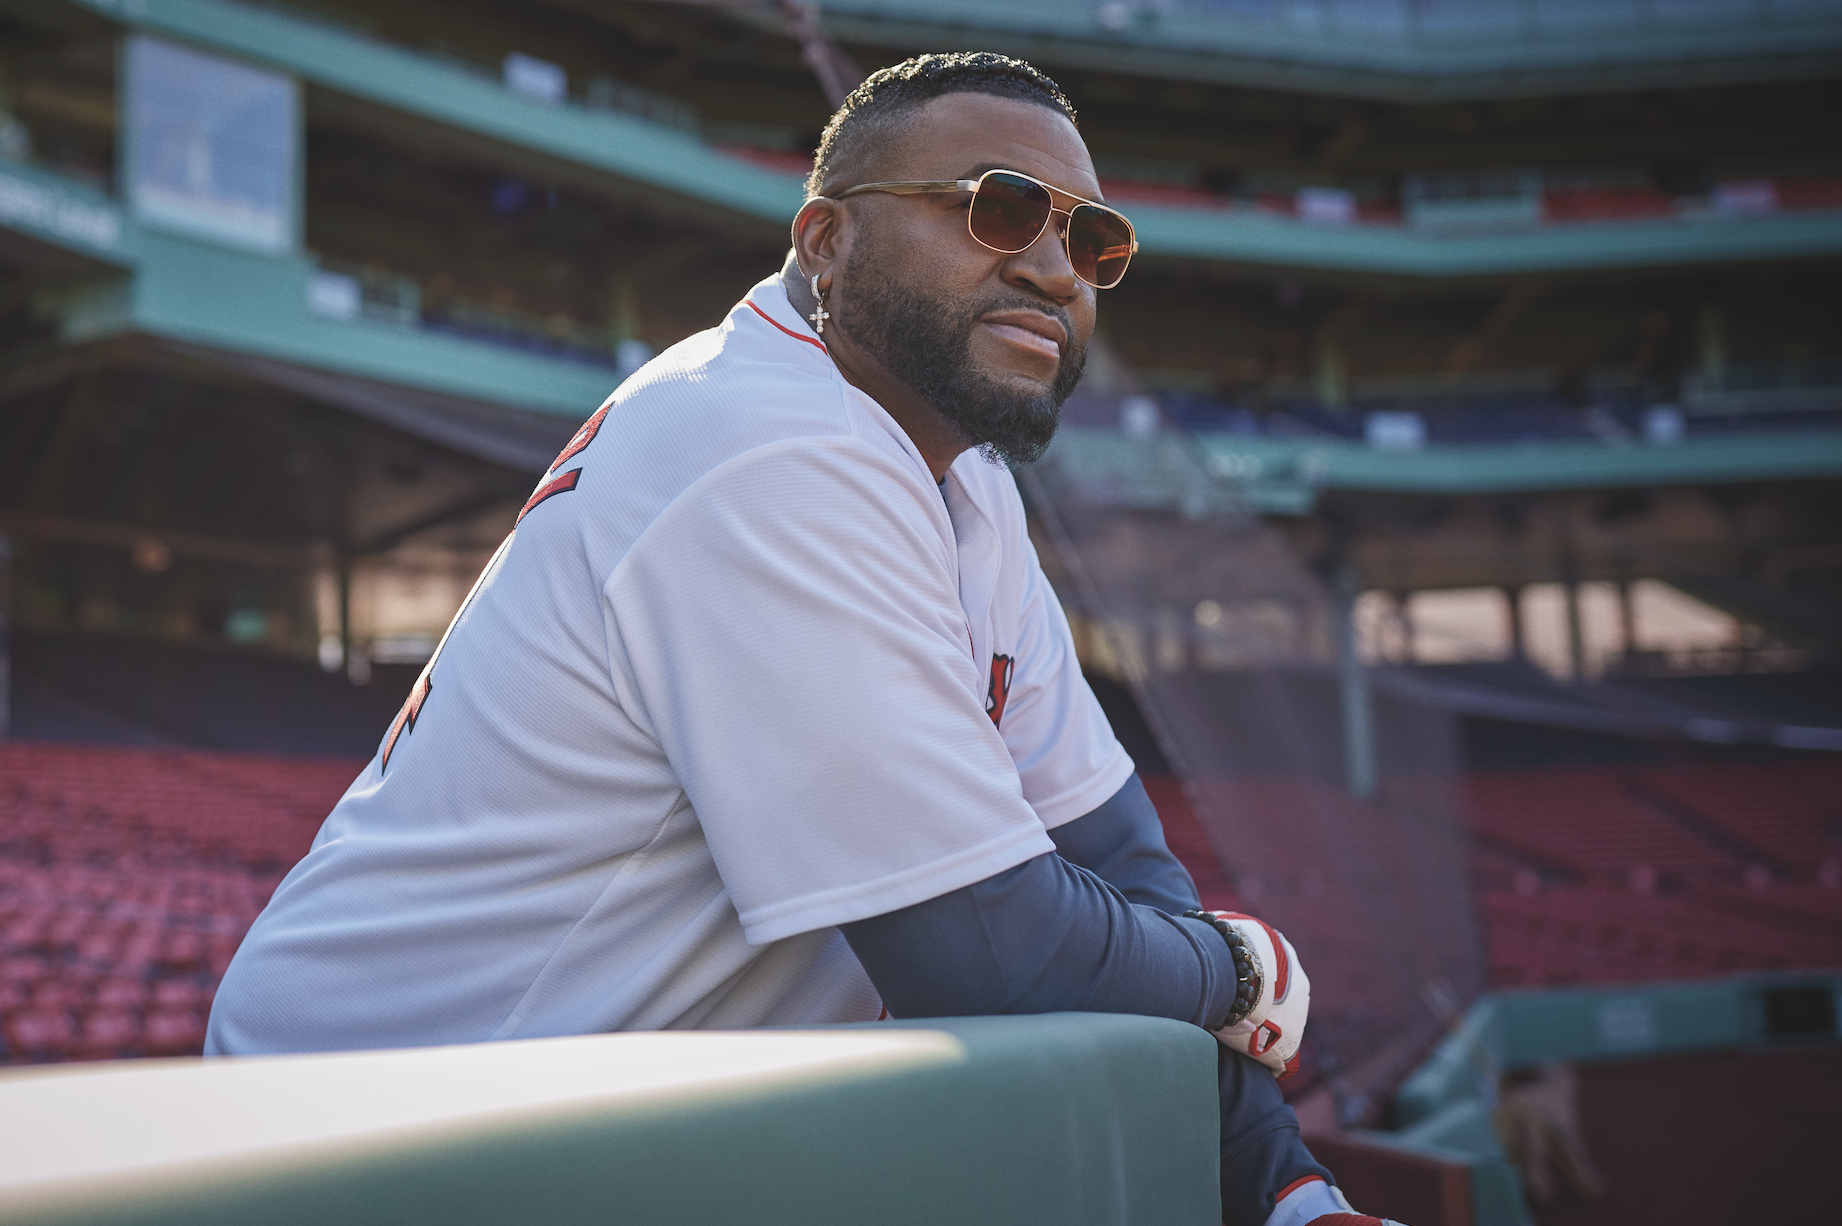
[879,94,1100,197]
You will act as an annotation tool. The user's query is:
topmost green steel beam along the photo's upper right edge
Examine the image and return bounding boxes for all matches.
[825,0,1842,103]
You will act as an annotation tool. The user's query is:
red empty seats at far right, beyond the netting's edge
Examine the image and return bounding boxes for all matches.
[1470,758,1842,987]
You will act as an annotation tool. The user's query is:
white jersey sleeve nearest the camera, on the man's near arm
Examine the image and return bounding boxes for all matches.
[602,438,1054,944]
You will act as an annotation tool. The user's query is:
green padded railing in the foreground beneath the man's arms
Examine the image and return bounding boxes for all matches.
[0,1014,1221,1226]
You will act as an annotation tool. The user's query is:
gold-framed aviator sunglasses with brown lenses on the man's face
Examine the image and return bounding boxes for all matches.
[831,171,1138,289]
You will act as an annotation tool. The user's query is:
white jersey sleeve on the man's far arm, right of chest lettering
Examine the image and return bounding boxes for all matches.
[1002,526,1133,828]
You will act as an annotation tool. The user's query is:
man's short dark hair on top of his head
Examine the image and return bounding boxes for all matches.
[807,52,1079,195]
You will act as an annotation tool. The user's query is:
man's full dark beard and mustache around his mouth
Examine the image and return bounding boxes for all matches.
[834,243,1087,464]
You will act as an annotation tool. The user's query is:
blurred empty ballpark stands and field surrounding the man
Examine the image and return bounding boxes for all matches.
[0,0,1842,1226]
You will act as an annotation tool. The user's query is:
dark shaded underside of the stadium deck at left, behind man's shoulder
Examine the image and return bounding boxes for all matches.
[0,335,575,585]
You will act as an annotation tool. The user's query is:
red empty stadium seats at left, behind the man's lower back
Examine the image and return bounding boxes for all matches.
[0,740,359,1064]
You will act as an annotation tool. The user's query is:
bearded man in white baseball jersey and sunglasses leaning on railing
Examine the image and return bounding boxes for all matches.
[208,55,1374,1226]
